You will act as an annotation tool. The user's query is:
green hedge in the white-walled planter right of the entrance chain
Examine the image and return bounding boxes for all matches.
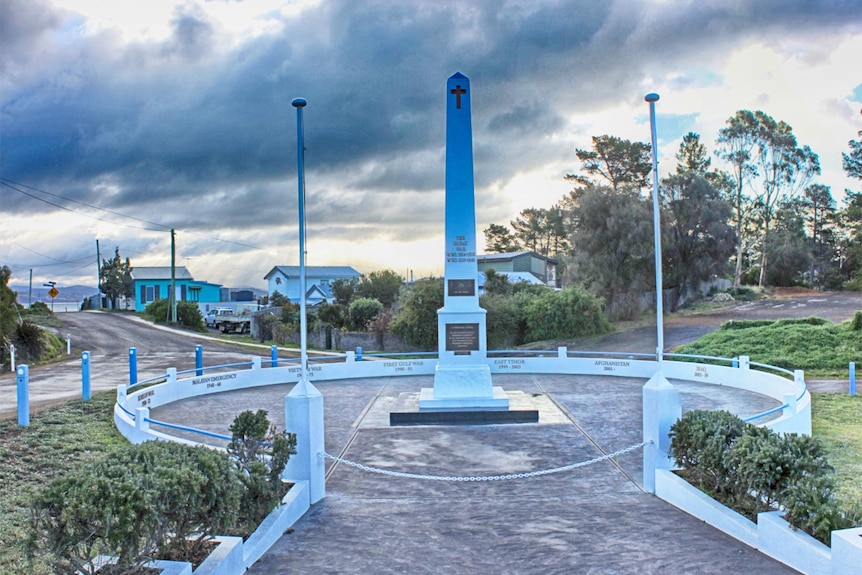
[670,410,862,545]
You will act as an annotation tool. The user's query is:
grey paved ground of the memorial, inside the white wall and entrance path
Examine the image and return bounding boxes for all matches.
[151,374,795,575]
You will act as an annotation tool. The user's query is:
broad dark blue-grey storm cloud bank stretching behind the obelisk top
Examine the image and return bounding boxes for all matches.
[0,0,862,236]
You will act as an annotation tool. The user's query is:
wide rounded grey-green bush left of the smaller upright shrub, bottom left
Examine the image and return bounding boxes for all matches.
[27,441,242,573]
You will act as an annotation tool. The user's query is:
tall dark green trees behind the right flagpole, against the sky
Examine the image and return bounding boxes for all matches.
[484,110,862,317]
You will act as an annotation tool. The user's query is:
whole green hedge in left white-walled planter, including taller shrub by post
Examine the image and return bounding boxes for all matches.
[25,410,296,575]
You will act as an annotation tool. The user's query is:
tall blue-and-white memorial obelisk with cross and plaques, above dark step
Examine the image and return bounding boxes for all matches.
[419,72,509,411]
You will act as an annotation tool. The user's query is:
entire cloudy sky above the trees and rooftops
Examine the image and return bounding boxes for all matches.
[0,0,862,287]
